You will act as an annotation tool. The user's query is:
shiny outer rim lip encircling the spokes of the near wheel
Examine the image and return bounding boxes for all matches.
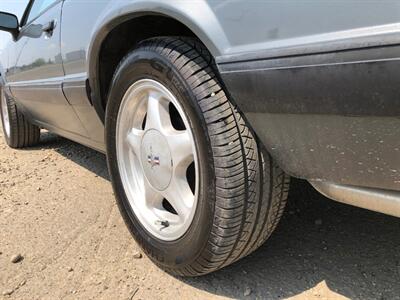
[116,79,199,241]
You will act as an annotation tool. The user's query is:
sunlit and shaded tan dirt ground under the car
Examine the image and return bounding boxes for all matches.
[0,127,400,299]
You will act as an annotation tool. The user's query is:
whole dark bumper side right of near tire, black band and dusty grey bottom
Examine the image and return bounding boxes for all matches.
[218,45,400,190]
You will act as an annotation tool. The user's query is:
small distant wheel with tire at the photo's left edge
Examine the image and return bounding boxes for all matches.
[0,89,40,149]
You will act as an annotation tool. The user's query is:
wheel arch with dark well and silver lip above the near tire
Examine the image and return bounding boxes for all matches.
[88,1,228,123]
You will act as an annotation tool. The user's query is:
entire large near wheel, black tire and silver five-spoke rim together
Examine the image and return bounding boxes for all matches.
[106,38,289,276]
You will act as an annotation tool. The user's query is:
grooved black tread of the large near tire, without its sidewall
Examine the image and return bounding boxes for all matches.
[114,37,289,276]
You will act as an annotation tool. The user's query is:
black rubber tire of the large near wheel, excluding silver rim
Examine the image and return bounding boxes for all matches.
[106,37,289,276]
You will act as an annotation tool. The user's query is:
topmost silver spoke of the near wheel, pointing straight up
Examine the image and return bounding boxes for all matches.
[146,91,171,131]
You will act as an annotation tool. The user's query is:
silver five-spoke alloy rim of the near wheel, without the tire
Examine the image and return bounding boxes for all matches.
[116,79,199,241]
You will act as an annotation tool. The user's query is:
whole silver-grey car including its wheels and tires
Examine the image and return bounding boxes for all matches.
[0,0,400,276]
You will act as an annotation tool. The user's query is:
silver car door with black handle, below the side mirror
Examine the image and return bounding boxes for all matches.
[8,0,87,136]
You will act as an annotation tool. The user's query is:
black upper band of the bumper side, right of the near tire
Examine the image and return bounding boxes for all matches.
[219,45,400,117]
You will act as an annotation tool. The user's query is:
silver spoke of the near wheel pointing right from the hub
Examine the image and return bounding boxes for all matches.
[167,130,193,175]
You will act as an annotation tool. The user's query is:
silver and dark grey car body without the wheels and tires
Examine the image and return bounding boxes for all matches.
[1,0,400,276]
